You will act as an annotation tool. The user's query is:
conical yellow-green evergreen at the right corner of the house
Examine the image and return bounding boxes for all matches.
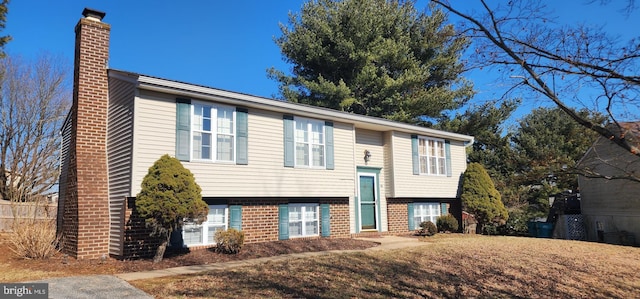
[460,163,509,230]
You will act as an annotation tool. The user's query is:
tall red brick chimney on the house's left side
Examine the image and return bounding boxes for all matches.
[59,8,111,259]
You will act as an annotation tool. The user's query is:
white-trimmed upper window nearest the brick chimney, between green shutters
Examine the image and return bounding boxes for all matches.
[191,103,235,162]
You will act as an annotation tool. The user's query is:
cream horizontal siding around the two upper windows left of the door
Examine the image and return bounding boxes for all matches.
[132,91,355,197]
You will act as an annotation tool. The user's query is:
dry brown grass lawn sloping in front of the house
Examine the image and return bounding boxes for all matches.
[131,234,640,298]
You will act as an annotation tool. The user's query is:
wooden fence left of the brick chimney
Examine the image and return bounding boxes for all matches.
[0,200,58,232]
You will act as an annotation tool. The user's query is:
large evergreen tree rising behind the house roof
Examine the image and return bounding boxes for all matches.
[269,0,473,124]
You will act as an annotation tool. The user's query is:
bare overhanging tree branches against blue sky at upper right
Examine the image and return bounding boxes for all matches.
[431,0,640,164]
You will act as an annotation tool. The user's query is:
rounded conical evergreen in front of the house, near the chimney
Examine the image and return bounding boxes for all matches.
[136,155,209,263]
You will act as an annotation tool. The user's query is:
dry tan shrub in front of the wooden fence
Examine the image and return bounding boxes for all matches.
[9,219,58,259]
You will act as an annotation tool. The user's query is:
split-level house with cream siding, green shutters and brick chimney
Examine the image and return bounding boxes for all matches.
[58,9,473,258]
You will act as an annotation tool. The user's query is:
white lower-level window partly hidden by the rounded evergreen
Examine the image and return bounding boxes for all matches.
[182,205,228,246]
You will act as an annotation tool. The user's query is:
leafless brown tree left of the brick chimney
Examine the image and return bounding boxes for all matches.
[0,55,71,206]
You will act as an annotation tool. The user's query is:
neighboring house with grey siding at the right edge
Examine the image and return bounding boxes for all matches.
[578,122,640,245]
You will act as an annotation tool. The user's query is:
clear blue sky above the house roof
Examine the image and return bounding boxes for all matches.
[2,0,640,118]
